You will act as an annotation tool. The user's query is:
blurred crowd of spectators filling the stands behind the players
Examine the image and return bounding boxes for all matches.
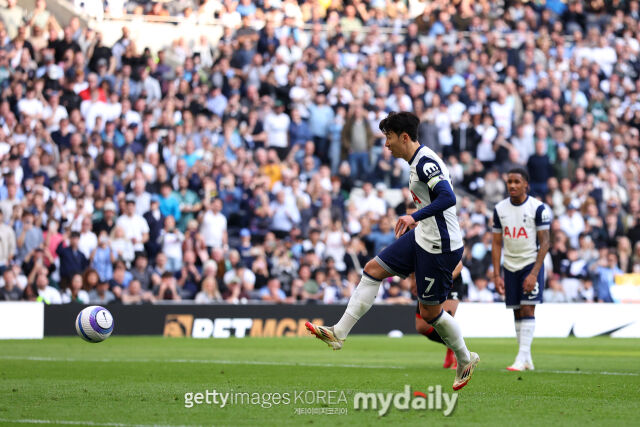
[0,0,640,304]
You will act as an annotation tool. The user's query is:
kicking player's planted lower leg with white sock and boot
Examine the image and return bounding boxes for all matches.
[420,303,480,390]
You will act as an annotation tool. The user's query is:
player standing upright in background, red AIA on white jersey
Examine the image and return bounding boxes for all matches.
[491,168,551,371]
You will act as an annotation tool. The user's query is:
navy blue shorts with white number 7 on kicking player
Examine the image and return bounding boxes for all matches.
[375,230,464,305]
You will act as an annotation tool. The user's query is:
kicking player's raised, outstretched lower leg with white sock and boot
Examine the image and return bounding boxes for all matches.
[305,259,391,350]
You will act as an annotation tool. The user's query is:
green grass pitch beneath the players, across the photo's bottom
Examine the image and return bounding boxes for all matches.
[0,336,640,427]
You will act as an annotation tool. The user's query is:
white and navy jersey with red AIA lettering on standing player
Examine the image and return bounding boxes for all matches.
[493,196,551,273]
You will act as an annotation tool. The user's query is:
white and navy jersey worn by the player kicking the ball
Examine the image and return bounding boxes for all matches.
[409,146,462,254]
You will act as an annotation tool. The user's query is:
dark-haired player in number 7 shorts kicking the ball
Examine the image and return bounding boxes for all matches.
[306,112,480,390]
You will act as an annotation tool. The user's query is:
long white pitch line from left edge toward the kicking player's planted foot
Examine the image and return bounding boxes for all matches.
[0,356,407,369]
